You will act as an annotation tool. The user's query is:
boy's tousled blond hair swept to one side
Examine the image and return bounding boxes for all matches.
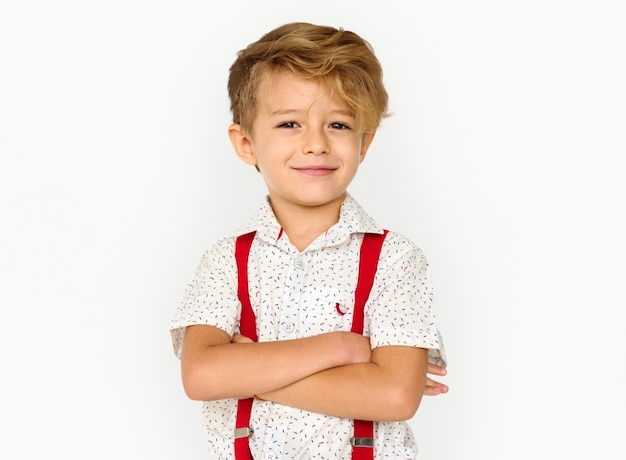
[228,22,390,134]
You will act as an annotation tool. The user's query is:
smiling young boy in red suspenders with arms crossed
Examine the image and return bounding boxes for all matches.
[171,23,447,460]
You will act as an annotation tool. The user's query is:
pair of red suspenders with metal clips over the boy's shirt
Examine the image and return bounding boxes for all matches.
[235,230,387,460]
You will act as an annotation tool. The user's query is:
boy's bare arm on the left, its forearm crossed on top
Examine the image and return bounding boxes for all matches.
[181,325,372,401]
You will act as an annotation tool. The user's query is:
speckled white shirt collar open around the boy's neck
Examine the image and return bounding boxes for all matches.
[233,193,383,249]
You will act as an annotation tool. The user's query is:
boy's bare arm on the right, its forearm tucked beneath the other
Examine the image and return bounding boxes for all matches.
[259,346,427,421]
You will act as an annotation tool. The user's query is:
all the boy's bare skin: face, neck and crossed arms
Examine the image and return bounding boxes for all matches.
[181,72,448,421]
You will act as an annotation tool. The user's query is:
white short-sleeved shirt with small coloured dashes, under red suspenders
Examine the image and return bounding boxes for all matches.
[171,194,445,460]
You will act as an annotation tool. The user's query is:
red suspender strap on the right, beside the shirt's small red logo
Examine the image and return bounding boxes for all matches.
[350,230,387,460]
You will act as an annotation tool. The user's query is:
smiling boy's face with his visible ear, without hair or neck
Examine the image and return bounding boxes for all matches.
[229,72,374,213]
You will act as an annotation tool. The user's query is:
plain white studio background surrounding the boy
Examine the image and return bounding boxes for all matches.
[0,0,626,460]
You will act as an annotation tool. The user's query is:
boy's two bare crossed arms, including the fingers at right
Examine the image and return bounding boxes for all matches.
[181,326,448,421]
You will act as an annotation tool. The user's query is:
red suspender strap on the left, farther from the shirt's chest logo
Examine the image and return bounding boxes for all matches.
[235,232,258,460]
